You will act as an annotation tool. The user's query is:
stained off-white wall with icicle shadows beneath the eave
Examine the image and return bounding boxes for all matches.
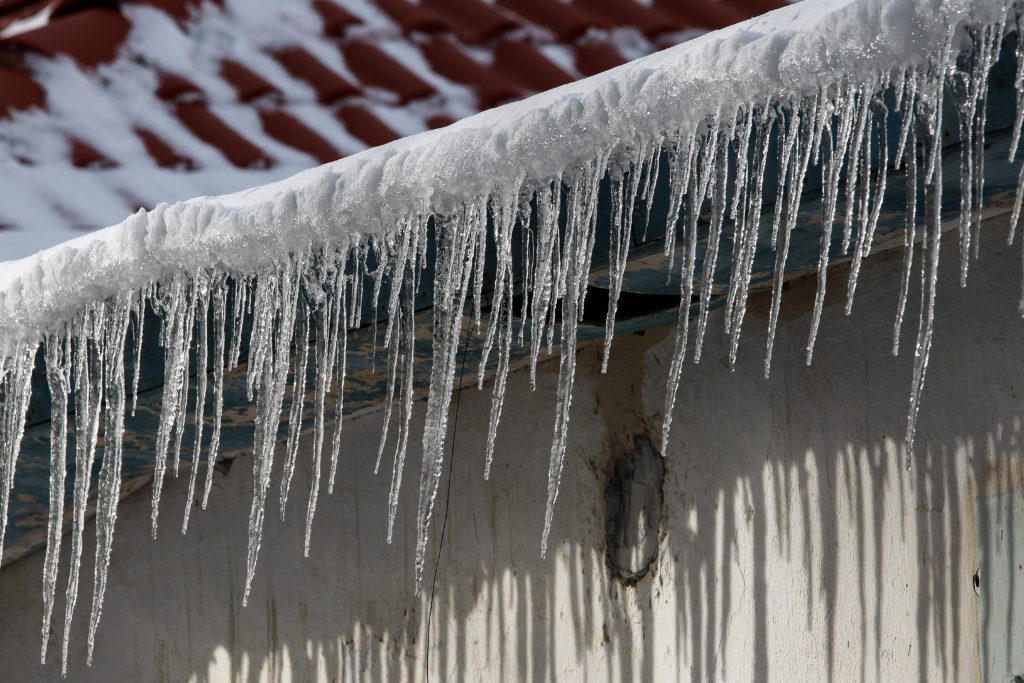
[0,215,1024,681]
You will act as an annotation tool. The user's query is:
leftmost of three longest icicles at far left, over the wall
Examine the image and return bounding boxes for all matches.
[40,331,71,664]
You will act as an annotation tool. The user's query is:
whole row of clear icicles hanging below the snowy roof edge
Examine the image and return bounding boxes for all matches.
[0,0,1024,667]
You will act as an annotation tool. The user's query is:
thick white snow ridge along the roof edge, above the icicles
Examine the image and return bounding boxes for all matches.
[0,0,983,349]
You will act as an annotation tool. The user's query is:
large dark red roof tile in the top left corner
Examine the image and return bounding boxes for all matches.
[0,8,131,69]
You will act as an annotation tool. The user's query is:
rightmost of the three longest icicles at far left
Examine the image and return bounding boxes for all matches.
[87,296,132,665]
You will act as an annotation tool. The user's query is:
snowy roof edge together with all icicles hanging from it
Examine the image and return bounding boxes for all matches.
[0,0,1024,667]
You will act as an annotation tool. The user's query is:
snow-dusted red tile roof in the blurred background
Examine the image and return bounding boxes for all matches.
[0,0,784,258]
